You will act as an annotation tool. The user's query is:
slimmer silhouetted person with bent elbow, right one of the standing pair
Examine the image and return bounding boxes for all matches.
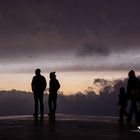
[48,72,60,116]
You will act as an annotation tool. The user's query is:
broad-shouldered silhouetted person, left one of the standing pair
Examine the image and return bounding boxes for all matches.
[31,69,47,118]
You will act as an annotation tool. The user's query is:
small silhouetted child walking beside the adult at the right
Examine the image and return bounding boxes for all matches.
[118,87,128,122]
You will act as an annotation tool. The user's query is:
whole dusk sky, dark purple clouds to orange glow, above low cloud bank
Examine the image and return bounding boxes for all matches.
[0,0,140,92]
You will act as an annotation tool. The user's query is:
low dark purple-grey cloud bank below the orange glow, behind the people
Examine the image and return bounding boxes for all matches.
[0,76,131,116]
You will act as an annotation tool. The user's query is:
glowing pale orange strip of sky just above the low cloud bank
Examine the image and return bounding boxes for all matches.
[0,71,140,94]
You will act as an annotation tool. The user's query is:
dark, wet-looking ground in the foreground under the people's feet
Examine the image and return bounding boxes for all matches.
[0,115,140,140]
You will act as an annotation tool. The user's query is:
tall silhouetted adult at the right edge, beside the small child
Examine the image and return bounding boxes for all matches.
[127,70,140,122]
